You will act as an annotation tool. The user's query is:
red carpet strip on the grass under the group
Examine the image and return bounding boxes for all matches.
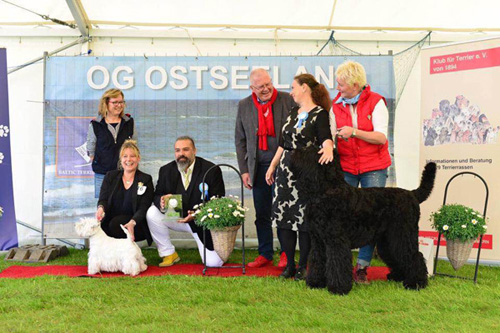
[0,264,389,281]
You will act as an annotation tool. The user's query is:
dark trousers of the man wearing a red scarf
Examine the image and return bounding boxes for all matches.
[252,164,281,260]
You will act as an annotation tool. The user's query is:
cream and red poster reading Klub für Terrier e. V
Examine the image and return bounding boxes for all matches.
[420,38,500,262]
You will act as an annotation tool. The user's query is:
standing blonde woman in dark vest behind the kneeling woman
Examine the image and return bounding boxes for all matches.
[87,89,137,198]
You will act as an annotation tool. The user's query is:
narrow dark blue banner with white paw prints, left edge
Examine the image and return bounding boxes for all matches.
[0,48,18,250]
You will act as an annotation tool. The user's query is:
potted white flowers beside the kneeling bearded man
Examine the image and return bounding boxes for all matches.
[194,197,248,262]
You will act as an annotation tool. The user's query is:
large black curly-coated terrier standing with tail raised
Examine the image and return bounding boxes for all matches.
[291,146,436,295]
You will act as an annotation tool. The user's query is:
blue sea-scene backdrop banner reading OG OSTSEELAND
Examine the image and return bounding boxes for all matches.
[43,56,395,238]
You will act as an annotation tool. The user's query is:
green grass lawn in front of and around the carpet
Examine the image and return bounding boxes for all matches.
[0,249,500,332]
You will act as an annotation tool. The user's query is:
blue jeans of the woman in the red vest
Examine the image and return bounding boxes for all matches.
[344,169,387,267]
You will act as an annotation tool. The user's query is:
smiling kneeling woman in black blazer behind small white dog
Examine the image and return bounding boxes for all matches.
[96,140,154,244]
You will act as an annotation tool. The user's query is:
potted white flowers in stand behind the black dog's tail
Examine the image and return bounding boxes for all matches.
[430,204,487,270]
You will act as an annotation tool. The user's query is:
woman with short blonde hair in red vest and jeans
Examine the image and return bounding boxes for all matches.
[330,61,391,284]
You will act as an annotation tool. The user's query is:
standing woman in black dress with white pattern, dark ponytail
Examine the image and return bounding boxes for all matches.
[266,74,333,280]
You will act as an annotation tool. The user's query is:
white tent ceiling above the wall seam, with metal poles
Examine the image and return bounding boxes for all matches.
[0,0,500,36]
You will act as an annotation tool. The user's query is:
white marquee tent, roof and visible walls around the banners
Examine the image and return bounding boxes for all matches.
[0,0,500,241]
